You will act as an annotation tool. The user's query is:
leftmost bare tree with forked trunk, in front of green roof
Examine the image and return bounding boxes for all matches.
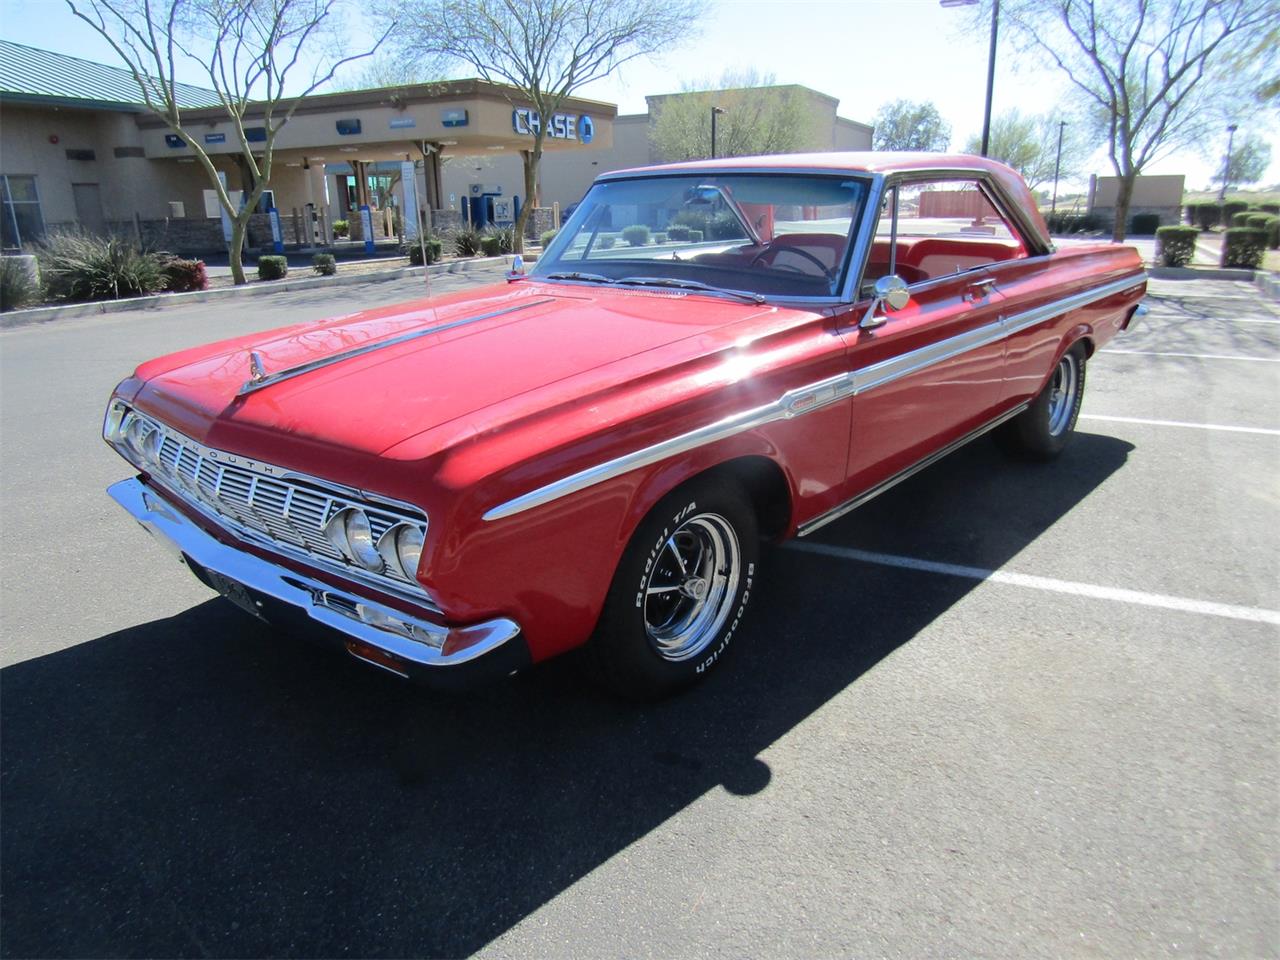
[67,0,389,284]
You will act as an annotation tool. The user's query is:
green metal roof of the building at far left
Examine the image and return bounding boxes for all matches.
[0,40,219,110]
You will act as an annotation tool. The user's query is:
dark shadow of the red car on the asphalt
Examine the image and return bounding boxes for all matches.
[0,434,1132,956]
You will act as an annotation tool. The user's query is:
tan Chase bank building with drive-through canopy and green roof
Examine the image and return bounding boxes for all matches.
[0,40,870,252]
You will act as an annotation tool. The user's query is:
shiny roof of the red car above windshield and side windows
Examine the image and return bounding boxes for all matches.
[596,151,1050,253]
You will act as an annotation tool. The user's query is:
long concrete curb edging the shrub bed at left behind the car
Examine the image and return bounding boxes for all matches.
[0,255,511,329]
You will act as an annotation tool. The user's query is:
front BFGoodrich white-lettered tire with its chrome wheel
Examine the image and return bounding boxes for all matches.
[590,479,760,699]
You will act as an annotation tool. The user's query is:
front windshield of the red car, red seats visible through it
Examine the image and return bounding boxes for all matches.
[532,173,867,297]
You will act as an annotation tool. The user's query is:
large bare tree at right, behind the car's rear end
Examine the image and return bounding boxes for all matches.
[1000,0,1280,242]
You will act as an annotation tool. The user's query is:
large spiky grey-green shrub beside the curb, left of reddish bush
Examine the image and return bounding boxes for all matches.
[36,232,170,301]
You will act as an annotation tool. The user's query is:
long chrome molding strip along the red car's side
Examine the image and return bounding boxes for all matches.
[484,275,1144,520]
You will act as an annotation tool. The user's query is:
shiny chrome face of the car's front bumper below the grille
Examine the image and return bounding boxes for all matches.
[106,477,520,678]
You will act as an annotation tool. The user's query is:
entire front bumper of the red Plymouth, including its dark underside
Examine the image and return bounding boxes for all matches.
[108,477,529,681]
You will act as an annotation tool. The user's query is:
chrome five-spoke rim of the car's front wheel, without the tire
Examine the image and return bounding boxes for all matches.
[644,513,742,662]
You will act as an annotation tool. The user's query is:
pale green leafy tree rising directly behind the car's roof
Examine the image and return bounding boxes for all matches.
[649,69,829,161]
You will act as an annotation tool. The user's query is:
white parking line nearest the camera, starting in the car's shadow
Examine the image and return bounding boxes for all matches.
[786,540,1280,626]
